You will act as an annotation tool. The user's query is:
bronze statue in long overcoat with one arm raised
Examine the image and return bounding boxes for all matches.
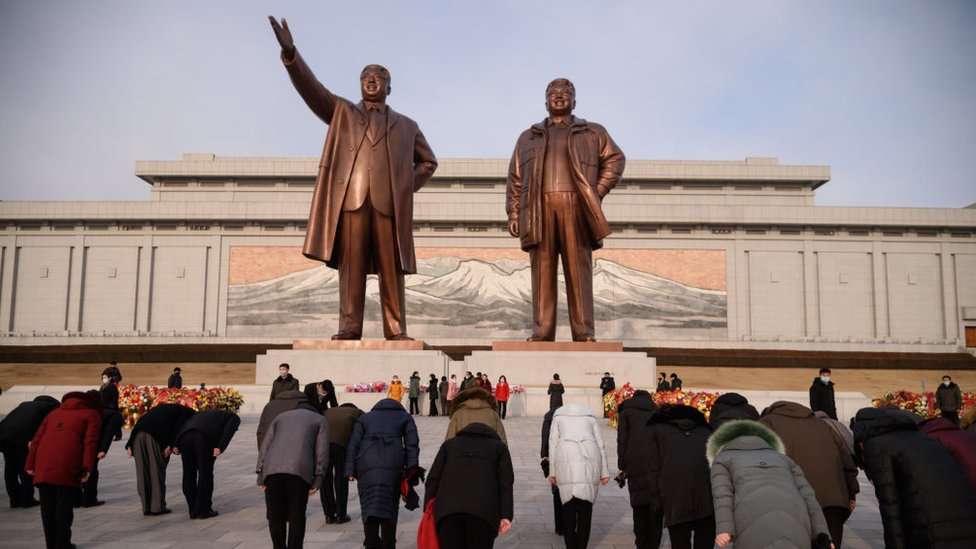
[269,17,437,339]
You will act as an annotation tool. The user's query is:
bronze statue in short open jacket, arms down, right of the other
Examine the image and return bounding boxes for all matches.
[505,78,624,341]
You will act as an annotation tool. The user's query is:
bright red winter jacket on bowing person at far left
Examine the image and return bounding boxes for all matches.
[24,393,102,486]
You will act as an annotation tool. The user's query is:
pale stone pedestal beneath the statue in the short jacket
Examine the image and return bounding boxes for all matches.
[451,348,657,390]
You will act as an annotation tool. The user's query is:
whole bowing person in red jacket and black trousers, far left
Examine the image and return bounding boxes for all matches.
[25,393,102,548]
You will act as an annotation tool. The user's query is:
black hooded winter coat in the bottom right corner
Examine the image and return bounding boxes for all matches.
[853,408,976,549]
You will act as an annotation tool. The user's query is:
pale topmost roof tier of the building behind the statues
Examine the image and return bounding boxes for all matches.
[136,153,830,188]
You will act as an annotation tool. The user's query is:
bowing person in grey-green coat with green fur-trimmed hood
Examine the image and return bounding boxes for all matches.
[708,420,833,549]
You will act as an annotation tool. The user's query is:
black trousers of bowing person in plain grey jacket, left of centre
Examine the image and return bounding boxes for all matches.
[264,473,309,549]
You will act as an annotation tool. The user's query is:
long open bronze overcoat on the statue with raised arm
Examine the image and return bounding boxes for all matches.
[284,51,437,274]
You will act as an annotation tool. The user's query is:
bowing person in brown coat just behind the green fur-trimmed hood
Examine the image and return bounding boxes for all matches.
[759,401,860,547]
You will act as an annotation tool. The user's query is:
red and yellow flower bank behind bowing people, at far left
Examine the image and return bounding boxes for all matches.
[119,385,244,427]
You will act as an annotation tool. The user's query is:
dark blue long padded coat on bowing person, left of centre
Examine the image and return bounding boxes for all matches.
[346,398,420,522]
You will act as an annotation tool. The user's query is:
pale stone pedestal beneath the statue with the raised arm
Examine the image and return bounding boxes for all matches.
[255,339,448,386]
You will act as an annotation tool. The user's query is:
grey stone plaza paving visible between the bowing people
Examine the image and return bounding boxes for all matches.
[0,417,884,549]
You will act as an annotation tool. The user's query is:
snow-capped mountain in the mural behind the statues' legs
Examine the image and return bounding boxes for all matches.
[227,249,727,343]
